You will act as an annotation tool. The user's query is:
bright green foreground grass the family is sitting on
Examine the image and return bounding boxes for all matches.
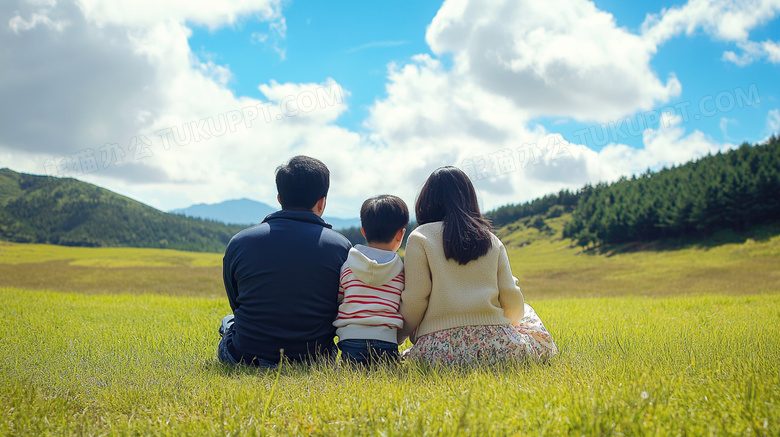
[0,288,780,435]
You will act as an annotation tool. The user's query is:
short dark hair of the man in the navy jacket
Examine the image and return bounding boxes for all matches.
[276,155,330,210]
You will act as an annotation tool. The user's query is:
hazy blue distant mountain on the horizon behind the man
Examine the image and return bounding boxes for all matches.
[170,198,360,229]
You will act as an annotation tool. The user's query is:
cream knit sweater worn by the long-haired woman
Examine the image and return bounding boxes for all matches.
[398,222,524,344]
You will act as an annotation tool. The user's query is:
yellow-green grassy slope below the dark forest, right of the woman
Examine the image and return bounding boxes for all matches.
[497,215,780,299]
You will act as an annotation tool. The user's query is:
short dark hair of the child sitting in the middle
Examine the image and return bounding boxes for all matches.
[360,194,409,243]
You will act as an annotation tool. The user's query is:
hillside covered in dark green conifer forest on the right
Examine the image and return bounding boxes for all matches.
[486,136,780,246]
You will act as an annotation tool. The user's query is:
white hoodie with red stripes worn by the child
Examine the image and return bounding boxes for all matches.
[333,244,404,343]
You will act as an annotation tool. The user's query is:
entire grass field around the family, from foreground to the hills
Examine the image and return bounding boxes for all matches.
[0,230,780,435]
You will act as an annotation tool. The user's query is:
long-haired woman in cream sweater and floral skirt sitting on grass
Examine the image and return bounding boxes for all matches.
[398,167,558,364]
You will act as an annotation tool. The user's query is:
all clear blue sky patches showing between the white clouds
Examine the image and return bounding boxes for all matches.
[189,1,780,149]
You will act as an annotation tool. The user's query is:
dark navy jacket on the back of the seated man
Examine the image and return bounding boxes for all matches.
[223,210,351,362]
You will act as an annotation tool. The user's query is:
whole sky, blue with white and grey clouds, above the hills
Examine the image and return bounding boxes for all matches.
[0,0,780,217]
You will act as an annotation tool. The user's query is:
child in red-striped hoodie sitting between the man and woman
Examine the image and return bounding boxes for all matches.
[333,194,409,364]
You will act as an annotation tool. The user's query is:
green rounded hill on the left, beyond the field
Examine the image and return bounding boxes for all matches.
[0,169,242,252]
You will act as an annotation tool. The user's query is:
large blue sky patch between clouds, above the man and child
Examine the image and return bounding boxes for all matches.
[189,0,440,135]
